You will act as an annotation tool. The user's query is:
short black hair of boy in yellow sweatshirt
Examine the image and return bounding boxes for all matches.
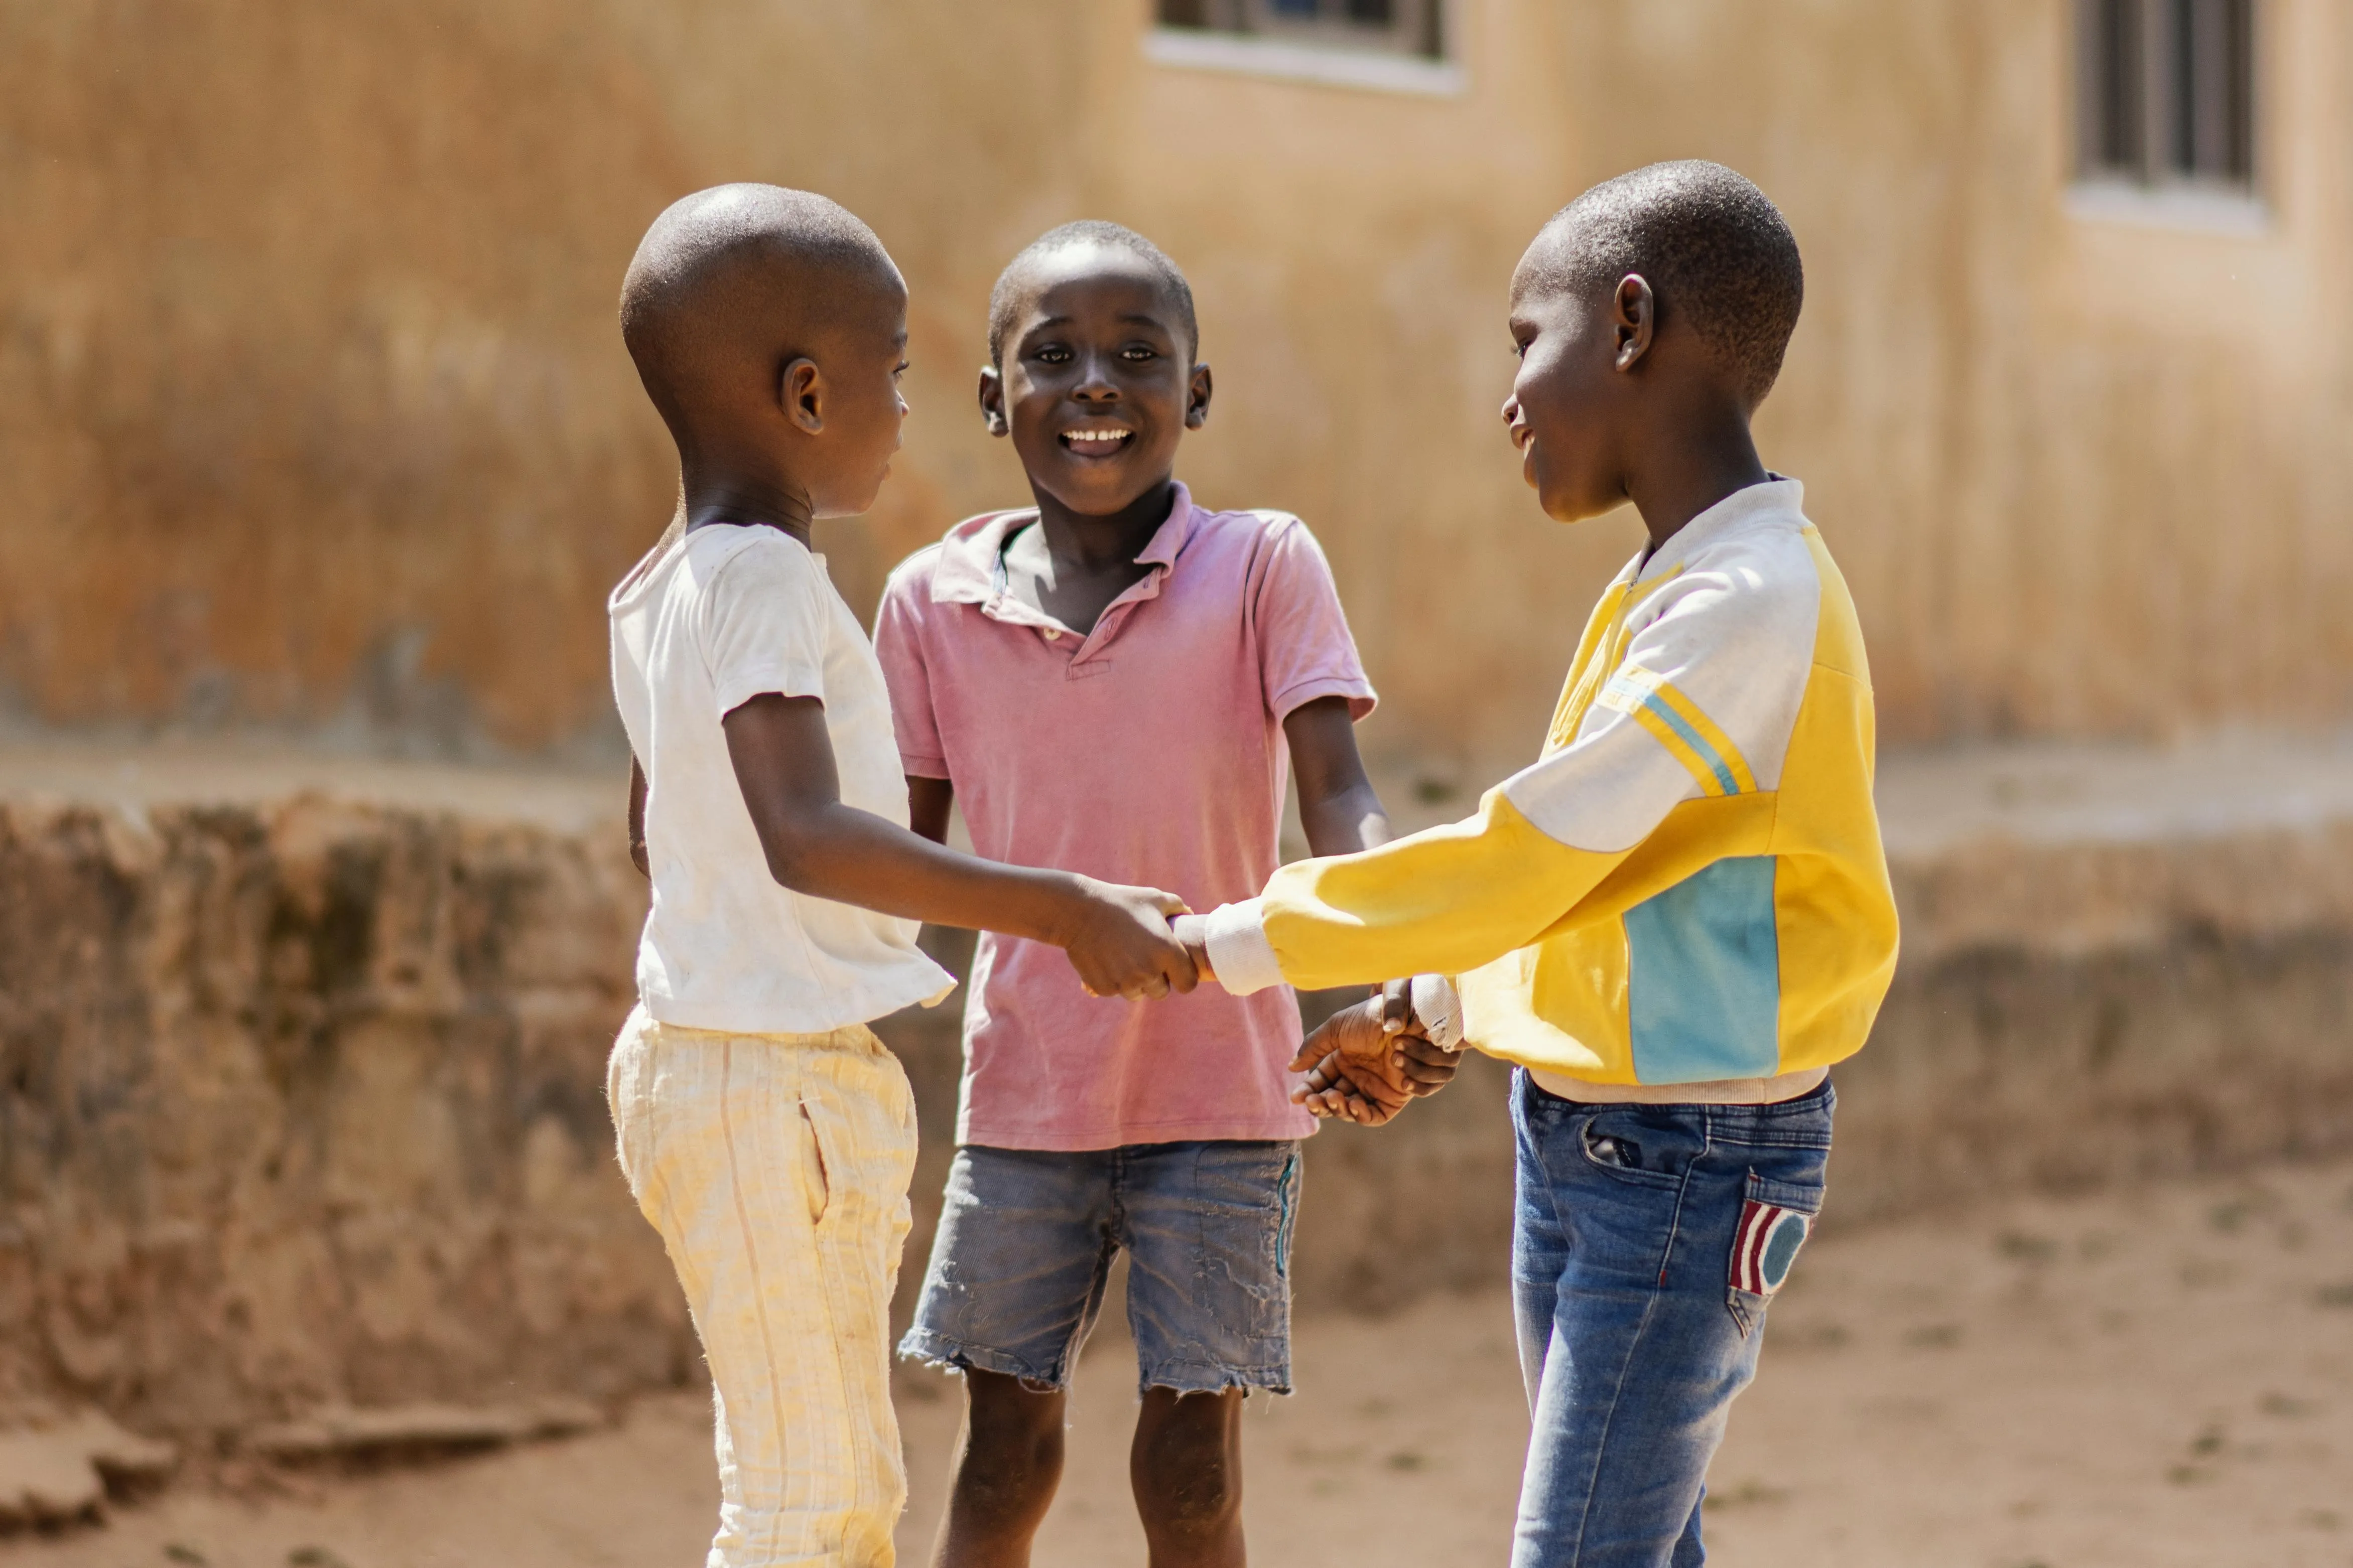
[1539,158,1805,402]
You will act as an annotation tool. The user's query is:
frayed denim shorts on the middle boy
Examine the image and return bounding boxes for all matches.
[899,1143,1299,1394]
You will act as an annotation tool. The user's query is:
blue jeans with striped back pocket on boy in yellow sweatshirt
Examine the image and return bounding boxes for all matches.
[1511,1072,1838,1568]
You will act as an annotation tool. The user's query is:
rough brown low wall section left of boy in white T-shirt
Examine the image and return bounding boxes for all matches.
[0,797,694,1434]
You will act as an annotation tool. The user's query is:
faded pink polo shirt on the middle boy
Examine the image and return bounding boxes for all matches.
[875,484,1374,1150]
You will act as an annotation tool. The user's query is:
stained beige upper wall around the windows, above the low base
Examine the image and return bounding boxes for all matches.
[0,0,2353,783]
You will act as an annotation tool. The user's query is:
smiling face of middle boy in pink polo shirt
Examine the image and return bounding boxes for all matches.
[981,242,1210,517]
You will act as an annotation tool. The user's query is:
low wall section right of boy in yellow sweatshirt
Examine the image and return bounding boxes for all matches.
[1836,820,2353,1218]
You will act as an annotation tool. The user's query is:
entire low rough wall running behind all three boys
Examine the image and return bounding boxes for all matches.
[0,757,2353,1437]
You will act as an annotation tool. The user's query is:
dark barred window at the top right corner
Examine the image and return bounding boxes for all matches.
[2075,0,2257,190]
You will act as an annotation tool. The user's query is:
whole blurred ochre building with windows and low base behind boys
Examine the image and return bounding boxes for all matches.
[0,0,2353,1532]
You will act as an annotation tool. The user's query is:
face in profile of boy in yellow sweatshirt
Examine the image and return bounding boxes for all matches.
[1504,233,1649,522]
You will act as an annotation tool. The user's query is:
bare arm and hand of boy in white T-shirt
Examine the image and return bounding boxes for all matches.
[720,691,1196,997]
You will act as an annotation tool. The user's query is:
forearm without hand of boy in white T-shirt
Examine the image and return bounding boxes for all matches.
[762,802,1082,945]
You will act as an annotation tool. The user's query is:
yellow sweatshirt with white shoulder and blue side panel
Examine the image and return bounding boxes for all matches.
[1207,480,1897,1084]
